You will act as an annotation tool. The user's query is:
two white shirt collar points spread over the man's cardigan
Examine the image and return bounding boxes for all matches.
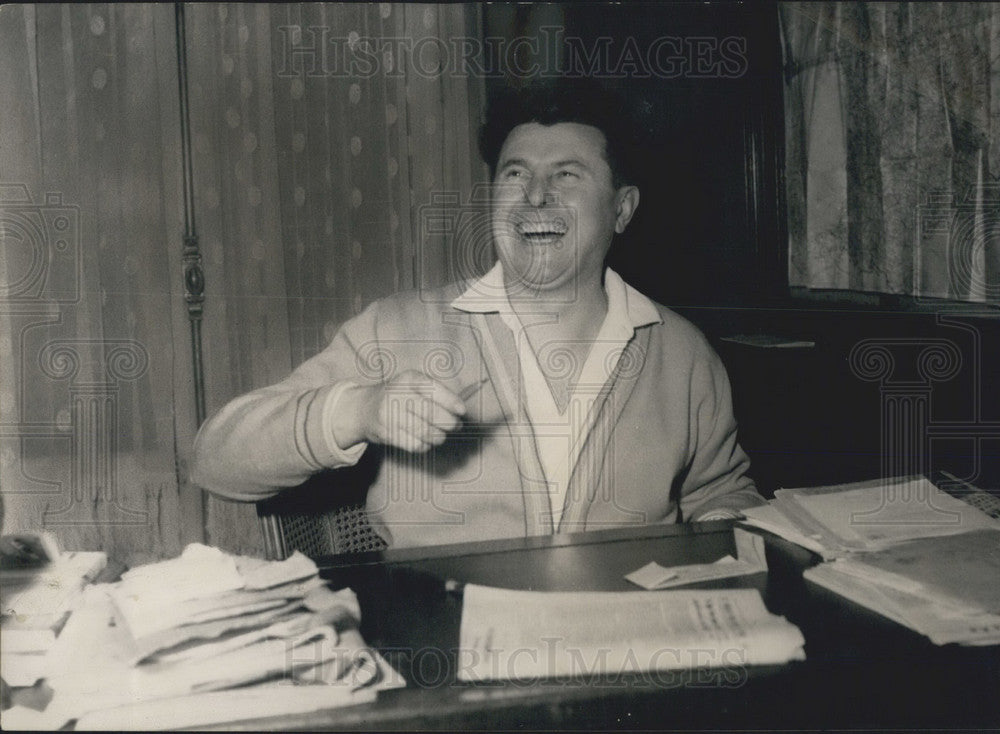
[451,261,663,331]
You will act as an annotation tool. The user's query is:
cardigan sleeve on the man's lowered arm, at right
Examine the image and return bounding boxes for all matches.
[680,343,764,521]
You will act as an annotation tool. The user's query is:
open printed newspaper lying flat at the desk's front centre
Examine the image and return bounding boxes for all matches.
[458,585,805,681]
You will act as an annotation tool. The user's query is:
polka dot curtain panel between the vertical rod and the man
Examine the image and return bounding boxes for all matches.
[188,3,486,542]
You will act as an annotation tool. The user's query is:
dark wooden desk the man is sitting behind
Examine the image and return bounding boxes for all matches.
[205,523,1000,731]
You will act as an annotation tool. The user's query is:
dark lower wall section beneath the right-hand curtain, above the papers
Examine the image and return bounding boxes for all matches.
[679,306,1000,495]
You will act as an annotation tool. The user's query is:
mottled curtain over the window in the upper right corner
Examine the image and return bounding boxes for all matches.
[780,2,1000,302]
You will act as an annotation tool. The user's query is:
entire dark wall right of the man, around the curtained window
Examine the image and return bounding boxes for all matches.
[486,2,1000,494]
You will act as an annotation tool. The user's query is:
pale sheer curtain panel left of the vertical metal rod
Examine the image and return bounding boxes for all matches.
[0,4,191,563]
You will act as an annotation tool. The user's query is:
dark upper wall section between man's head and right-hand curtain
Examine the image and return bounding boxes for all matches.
[485,2,787,305]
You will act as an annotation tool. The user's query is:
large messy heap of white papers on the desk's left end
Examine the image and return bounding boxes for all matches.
[4,544,401,729]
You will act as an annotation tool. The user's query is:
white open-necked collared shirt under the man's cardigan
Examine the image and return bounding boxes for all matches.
[451,262,661,528]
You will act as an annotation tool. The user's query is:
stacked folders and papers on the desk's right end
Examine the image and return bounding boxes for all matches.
[744,477,1000,645]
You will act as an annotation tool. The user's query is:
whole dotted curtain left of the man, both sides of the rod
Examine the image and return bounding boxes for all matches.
[0,3,484,563]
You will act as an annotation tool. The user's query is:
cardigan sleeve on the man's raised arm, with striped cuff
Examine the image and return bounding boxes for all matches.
[191,303,381,502]
